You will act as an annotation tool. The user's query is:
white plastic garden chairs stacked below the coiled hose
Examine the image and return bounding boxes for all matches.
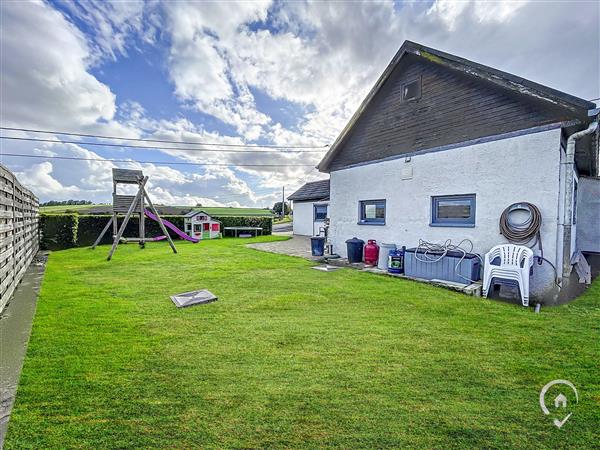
[483,244,533,306]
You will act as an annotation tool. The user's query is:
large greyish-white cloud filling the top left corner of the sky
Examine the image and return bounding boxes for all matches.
[0,2,115,128]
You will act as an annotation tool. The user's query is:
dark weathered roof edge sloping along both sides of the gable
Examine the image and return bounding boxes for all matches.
[317,41,596,172]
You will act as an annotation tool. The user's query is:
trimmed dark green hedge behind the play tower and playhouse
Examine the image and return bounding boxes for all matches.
[41,214,273,250]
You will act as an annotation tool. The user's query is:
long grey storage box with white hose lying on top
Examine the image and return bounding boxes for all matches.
[404,248,481,284]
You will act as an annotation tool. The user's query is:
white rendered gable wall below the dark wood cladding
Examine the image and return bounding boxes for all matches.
[329,129,562,302]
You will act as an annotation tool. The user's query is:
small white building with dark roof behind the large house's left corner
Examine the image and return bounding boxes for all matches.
[288,180,329,236]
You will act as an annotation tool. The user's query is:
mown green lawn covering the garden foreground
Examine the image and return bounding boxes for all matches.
[6,237,600,449]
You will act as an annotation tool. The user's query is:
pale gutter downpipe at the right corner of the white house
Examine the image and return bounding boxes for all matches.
[559,121,598,278]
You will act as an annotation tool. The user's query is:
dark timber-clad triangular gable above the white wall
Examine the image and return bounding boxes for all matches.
[327,55,573,171]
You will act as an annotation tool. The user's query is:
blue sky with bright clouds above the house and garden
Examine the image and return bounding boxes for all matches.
[0,0,600,207]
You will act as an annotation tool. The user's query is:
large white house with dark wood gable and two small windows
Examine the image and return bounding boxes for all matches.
[318,41,600,303]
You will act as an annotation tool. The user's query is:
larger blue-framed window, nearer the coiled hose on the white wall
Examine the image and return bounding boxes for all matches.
[431,194,475,227]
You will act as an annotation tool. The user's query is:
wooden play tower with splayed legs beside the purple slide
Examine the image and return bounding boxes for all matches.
[92,169,177,261]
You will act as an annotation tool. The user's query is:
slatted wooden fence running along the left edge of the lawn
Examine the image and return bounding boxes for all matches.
[0,164,40,312]
